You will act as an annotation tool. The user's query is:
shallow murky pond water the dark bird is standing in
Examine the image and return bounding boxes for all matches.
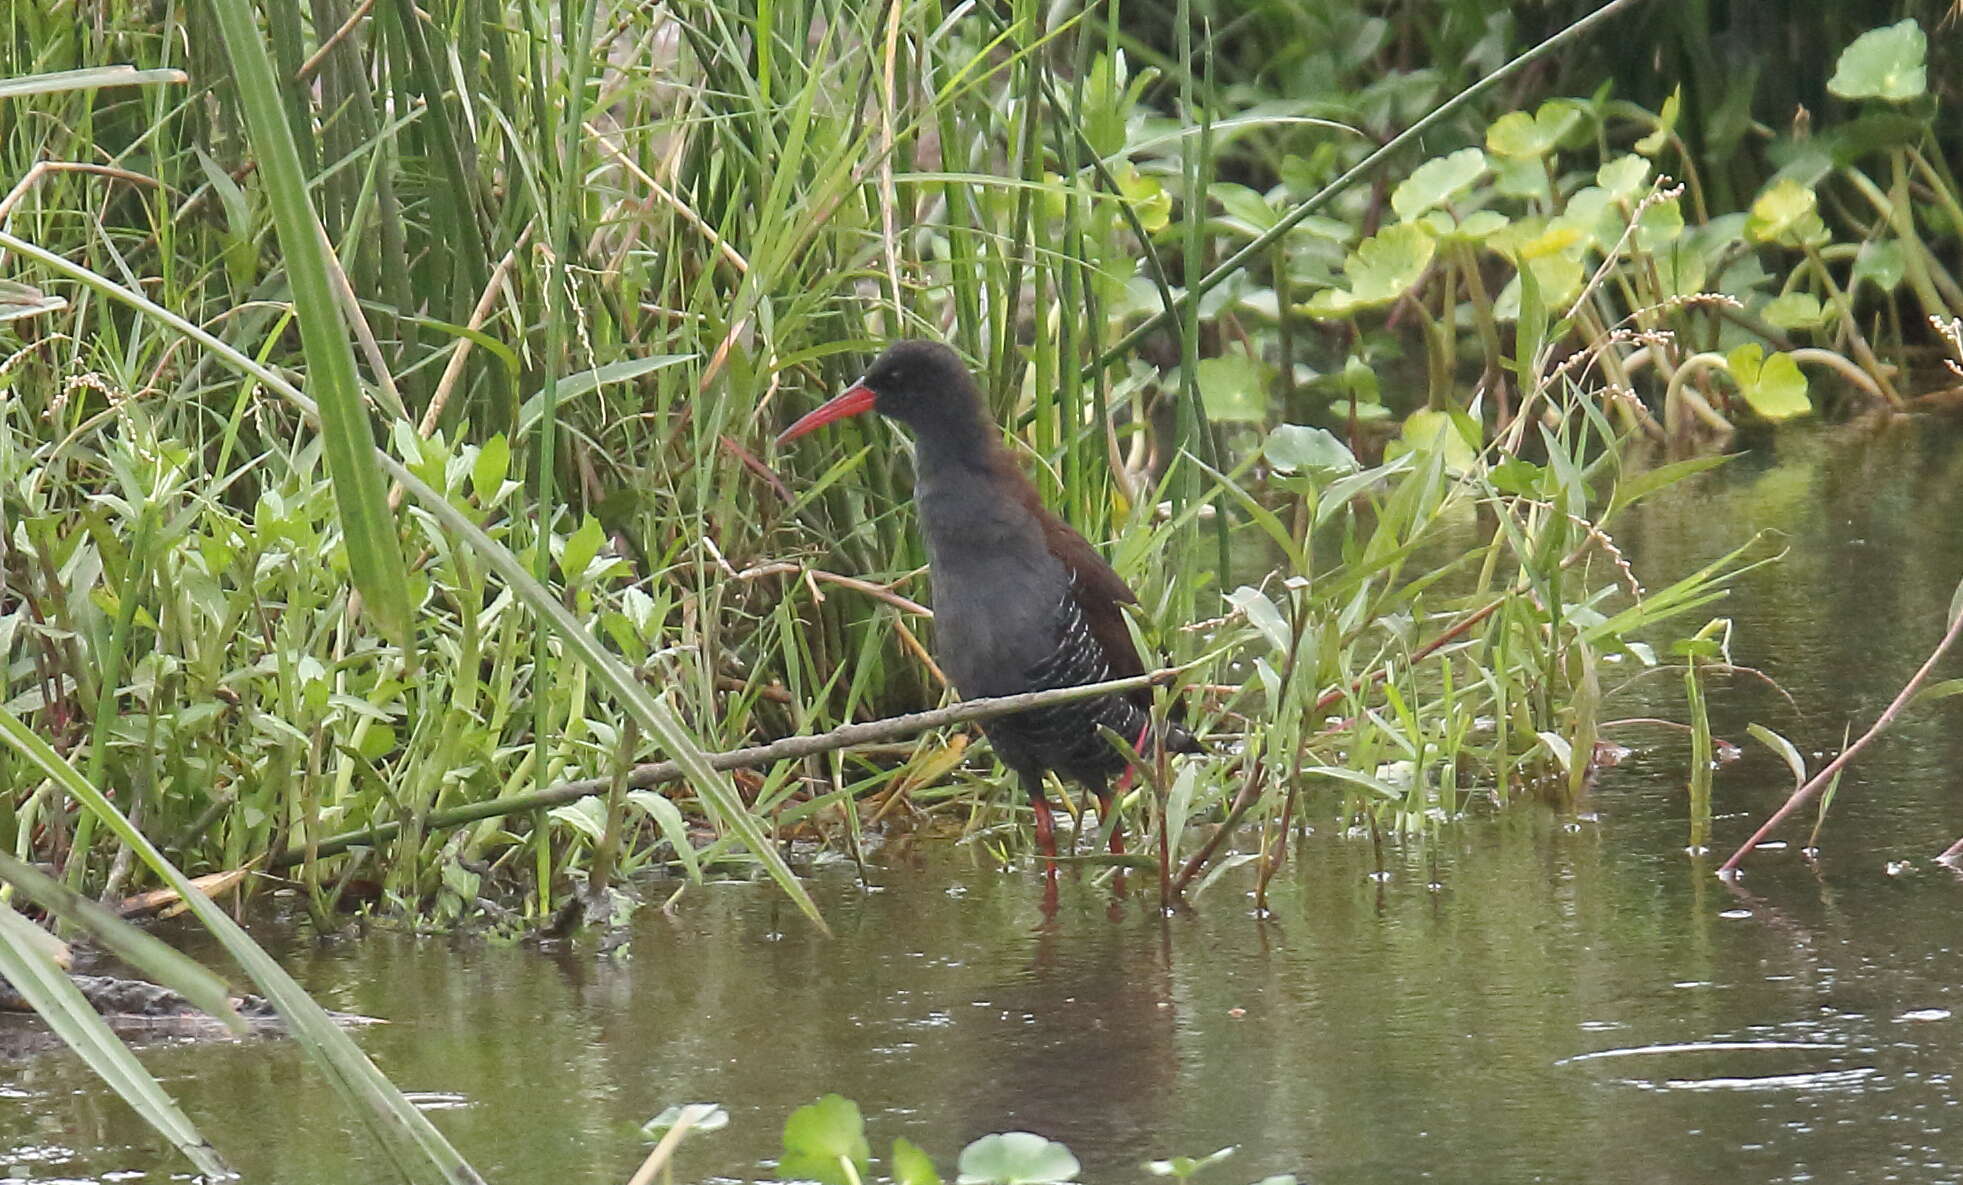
[0,426,1963,1185]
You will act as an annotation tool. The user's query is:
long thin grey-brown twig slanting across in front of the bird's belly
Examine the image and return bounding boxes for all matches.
[271,653,1215,869]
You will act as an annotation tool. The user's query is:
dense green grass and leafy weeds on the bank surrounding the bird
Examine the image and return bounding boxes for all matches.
[0,0,1860,924]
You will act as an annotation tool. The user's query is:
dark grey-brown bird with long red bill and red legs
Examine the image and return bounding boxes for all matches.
[777,339,1201,885]
